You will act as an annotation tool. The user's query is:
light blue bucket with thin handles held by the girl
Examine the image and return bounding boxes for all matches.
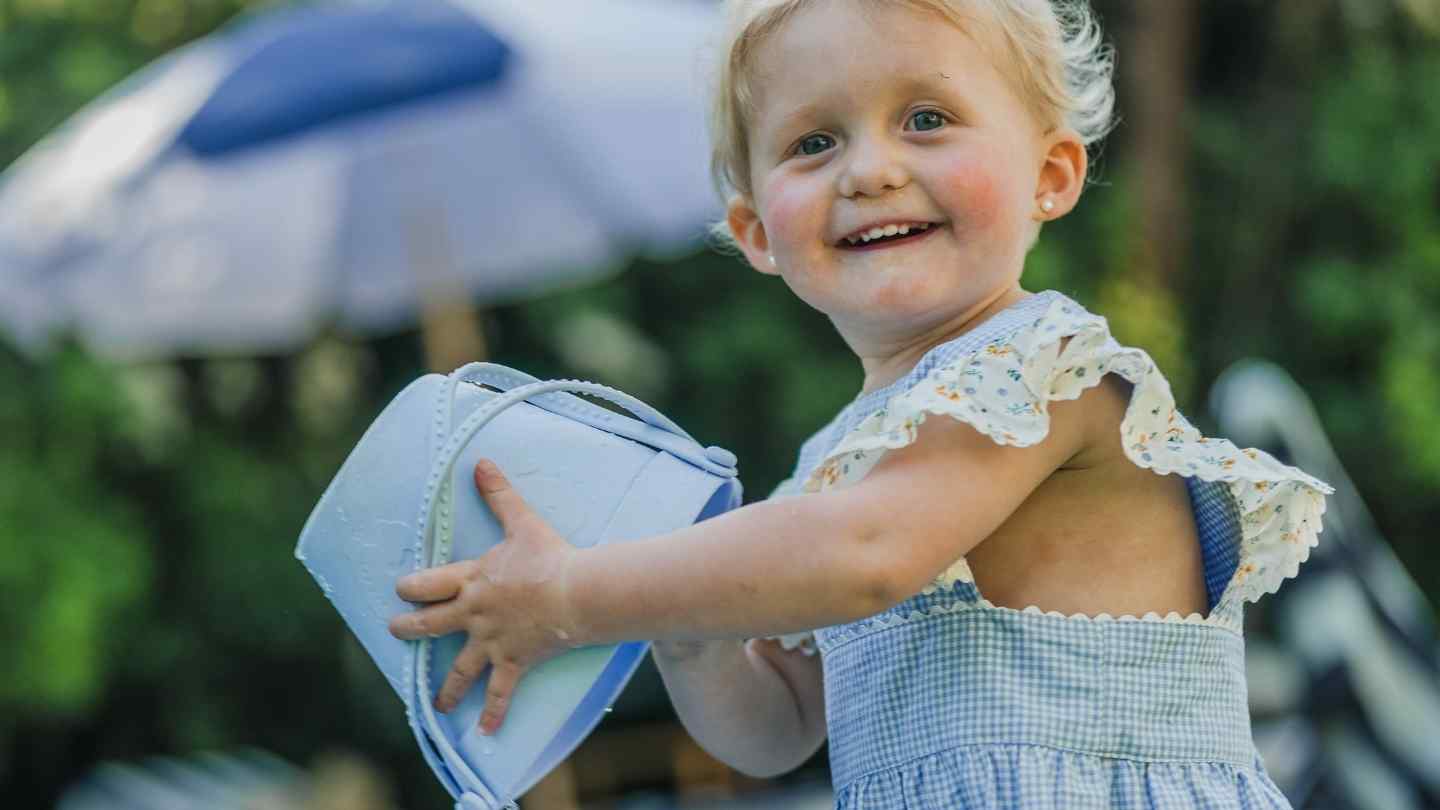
[295,363,740,810]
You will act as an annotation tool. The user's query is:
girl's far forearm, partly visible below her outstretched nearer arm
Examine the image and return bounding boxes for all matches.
[651,638,825,778]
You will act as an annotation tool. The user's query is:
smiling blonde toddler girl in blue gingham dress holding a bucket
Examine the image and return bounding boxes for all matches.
[392,0,1331,810]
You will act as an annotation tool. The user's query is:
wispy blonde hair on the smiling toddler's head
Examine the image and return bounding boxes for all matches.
[710,0,1115,245]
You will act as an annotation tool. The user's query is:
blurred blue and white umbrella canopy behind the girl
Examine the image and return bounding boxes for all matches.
[0,0,720,359]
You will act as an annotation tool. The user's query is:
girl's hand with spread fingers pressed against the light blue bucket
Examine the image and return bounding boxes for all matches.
[390,460,576,734]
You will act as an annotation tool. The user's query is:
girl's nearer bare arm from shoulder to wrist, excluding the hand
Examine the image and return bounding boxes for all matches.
[555,392,1083,643]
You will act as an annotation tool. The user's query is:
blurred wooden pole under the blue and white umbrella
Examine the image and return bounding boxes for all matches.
[406,206,485,373]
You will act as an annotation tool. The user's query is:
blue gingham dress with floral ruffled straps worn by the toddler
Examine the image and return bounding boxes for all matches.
[775,291,1332,810]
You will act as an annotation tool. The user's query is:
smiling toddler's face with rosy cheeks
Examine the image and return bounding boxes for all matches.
[732,0,1084,337]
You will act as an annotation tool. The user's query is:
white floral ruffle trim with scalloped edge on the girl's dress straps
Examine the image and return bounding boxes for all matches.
[804,295,1333,601]
